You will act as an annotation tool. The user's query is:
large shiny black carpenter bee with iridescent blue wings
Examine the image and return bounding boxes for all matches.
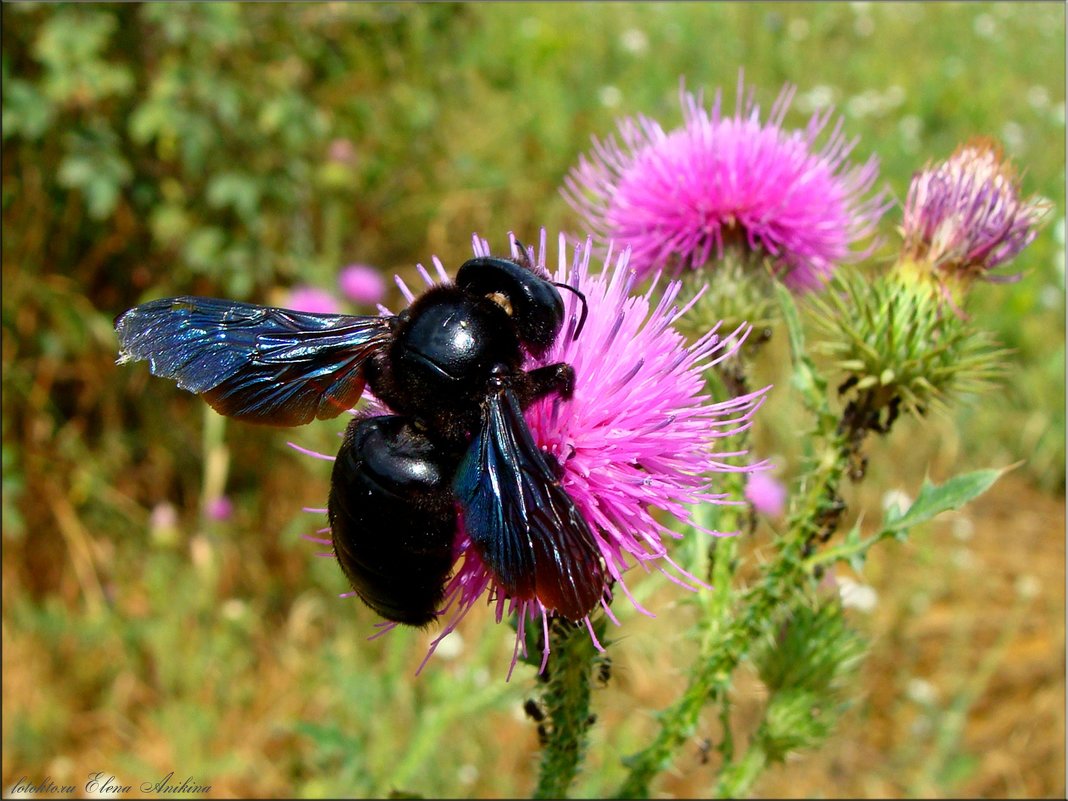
[115,250,604,626]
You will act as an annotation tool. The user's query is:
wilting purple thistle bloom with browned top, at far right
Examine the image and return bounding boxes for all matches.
[901,140,1050,296]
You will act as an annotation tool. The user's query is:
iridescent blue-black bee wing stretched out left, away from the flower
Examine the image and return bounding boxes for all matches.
[115,297,393,425]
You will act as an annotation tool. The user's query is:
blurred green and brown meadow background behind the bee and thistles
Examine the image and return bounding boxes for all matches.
[2,2,1065,797]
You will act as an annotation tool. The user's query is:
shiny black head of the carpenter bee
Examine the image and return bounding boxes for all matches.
[456,256,564,355]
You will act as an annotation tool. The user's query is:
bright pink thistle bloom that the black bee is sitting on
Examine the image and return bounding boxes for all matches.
[299,232,767,679]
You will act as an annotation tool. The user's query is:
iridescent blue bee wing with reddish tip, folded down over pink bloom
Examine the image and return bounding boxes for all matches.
[453,389,604,621]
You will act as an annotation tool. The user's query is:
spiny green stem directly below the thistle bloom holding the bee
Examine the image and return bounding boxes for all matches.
[534,621,597,798]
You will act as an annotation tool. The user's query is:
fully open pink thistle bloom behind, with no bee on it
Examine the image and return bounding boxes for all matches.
[564,78,889,289]
